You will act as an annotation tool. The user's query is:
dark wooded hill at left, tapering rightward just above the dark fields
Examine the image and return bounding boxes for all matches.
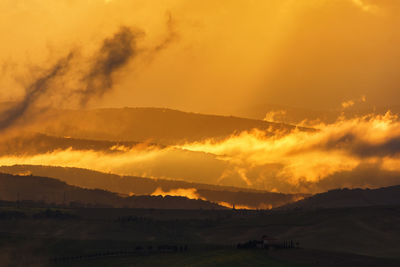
[0,173,224,209]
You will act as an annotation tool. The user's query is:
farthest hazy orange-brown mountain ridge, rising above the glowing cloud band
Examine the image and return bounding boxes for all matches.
[26,108,310,145]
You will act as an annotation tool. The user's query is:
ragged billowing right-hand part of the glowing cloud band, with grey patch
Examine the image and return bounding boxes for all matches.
[176,113,400,192]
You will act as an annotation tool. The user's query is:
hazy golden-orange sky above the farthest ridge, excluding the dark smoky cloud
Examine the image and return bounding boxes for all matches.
[0,0,400,115]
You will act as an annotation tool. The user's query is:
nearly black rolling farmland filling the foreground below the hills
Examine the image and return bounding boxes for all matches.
[0,206,400,266]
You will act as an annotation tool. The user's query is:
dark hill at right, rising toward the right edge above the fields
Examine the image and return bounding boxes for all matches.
[282,185,400,209]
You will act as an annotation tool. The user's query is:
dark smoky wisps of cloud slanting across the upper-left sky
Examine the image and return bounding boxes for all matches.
[0,22,176,131]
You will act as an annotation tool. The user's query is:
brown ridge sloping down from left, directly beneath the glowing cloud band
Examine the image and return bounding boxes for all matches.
[0,165,309,209]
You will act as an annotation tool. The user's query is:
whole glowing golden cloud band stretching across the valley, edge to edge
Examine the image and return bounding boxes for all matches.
[0,112,400,193]
